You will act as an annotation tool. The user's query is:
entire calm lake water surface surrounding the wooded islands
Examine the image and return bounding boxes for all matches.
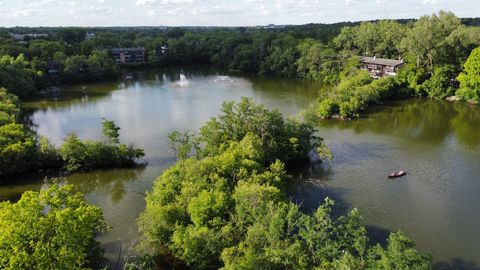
[0,70,480,269]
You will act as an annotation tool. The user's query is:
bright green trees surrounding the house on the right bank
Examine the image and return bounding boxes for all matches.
[305,11,480,119]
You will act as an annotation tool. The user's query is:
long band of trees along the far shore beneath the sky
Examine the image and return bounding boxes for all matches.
[0,11,480,104]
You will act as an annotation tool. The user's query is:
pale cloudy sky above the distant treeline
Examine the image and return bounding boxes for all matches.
[0,0,480,27]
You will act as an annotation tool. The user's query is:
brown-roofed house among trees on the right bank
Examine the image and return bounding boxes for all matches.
[360,57,403,79]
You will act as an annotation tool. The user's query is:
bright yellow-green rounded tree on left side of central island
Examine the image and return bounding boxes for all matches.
[140,134,268,269]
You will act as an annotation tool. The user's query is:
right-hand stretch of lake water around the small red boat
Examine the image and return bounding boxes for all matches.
[295,100,480,269]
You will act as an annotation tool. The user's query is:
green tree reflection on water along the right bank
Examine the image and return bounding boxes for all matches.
[320,100,480,147]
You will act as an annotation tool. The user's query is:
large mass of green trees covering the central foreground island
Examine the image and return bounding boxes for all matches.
[139,100,431,269]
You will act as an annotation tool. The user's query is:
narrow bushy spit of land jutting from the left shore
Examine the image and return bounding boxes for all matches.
[0,88,144,177]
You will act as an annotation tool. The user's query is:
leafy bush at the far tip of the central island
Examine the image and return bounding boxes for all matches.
[198,98,323,164]
